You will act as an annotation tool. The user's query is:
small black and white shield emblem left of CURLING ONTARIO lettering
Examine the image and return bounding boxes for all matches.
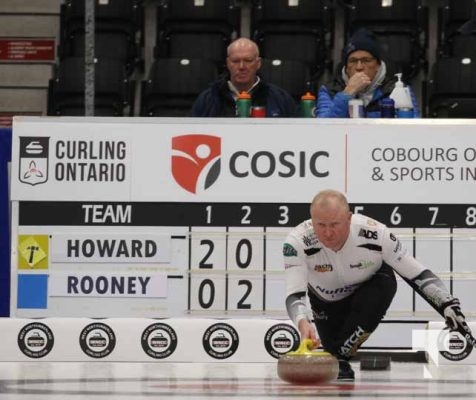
[18,137,50,186]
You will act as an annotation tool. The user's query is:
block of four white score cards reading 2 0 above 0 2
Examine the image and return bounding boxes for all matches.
[189,227,266,314]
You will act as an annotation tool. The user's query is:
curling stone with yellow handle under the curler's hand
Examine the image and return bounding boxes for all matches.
[278,339,339,384]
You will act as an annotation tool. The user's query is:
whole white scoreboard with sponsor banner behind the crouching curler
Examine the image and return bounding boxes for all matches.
[11,117,476,318]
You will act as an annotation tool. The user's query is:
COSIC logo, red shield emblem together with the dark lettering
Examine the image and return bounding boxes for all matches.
[172,134,330,194]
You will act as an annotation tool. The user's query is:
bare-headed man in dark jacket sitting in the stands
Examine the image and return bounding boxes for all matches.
[191,38,297,117]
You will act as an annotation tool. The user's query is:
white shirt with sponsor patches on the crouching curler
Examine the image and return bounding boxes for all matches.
[283,214,425,302]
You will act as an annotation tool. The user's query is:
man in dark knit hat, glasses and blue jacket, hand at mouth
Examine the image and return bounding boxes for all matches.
[317,29,420,118]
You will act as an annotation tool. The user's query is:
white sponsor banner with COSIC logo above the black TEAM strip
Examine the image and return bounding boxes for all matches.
[12,117,476,203]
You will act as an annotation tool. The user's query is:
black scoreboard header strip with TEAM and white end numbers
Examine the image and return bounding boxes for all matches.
[19,201,476,228]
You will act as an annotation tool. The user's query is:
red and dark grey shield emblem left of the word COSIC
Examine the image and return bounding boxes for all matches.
[172,135,221,194]
